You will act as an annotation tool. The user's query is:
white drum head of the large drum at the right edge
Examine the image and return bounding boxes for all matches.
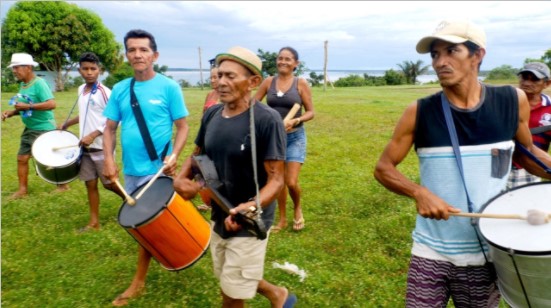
[478,182,551,255]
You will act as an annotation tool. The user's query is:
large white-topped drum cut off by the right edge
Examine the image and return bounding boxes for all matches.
[478,182,551,308]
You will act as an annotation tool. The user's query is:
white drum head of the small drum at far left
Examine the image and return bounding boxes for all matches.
[31,130,80,168]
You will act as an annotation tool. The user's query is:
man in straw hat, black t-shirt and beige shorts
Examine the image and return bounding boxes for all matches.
[174,47,297,307]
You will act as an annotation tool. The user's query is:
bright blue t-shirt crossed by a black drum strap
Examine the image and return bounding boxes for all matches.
[103,74,189,176]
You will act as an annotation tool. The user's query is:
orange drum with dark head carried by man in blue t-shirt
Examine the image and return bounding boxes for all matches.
[119,177,211,271]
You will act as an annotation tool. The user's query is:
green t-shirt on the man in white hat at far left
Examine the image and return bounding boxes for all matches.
[18,77,56,130]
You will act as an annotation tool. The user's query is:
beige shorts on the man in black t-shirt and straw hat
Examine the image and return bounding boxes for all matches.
[210,222,269,299]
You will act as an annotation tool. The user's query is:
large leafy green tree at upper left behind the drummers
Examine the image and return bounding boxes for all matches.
[2,1,123,91]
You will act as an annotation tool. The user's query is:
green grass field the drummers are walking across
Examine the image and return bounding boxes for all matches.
[2,85,532,307]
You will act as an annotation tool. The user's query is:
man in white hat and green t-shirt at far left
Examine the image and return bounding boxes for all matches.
[2,53,68,199]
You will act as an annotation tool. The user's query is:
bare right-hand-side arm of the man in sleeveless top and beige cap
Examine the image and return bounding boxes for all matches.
[513,89,551,179]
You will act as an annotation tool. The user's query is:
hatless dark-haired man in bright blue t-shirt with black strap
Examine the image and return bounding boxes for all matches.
[103,29,189,306]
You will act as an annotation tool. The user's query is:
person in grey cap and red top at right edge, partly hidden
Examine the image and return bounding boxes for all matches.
[507,62,551,189]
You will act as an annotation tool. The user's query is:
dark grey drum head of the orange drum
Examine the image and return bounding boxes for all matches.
[119,176,174,228]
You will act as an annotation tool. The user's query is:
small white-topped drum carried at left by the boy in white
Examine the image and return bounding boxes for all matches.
[31,130,81,184]
